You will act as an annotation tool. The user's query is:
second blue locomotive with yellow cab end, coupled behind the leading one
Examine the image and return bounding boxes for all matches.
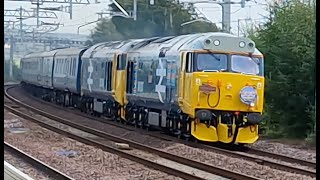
[82,40,142,115]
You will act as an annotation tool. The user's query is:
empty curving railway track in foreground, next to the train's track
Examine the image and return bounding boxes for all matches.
[5,84,259,180]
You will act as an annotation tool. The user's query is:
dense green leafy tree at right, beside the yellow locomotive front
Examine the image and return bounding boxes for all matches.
[253,1,316,138]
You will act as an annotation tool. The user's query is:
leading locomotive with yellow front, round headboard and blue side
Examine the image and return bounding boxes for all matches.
[123,33,264,144]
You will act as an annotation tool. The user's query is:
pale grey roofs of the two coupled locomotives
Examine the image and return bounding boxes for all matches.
[83,32,262,58]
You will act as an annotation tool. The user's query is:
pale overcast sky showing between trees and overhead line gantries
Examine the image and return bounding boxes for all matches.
[4,0,268,35]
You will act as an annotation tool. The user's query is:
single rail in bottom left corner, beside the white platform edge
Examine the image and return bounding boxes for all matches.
[4,141,73,180]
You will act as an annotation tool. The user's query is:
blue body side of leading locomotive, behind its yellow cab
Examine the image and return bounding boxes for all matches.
[123,35,206,129]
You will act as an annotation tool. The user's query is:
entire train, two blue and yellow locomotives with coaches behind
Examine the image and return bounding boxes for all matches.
[21,32,264,144]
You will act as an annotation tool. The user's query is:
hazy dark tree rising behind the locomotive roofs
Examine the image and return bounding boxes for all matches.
[91,0,219,43]
